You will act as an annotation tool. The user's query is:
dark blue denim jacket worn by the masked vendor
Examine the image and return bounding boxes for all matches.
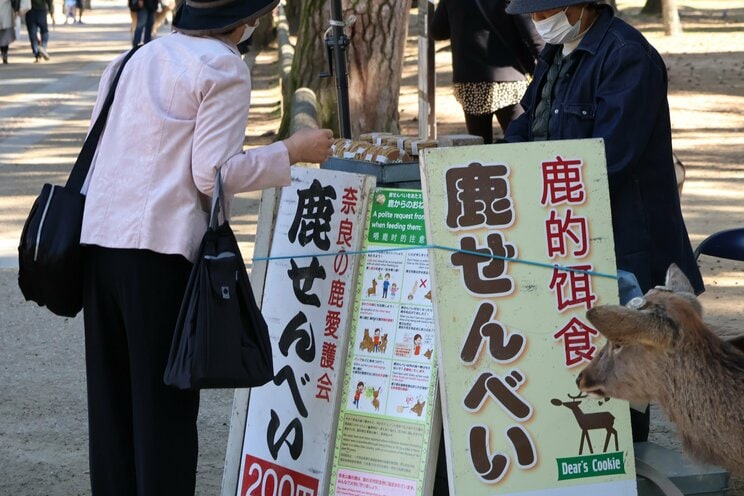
[505,6,703,293]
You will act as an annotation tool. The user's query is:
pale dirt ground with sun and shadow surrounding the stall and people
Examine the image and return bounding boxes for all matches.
[0,0,744,496]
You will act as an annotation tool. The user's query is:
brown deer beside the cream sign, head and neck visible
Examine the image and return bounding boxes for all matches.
[576,264,744,474]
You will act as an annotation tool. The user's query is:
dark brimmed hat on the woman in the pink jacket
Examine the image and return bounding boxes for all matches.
[173,0,279,35]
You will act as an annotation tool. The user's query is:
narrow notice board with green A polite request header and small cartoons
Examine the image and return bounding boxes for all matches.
[329,189,439,496]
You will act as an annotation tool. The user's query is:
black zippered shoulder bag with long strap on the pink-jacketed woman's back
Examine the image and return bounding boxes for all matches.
[18,48,142,317]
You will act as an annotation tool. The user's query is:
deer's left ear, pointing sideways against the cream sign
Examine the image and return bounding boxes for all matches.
[586,305,664,348]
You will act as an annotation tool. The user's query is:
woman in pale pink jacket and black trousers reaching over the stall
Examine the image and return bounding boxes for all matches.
[81,0,332,496]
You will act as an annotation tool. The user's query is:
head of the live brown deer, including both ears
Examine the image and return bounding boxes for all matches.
[576,264,707,402]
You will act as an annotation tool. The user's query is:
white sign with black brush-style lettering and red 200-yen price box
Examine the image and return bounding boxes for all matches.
[237,167,374,496]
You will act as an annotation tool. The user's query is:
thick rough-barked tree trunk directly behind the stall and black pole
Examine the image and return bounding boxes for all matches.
[279,0,409,136]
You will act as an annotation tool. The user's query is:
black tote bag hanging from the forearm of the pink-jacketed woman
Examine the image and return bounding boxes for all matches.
[163,172,274,389]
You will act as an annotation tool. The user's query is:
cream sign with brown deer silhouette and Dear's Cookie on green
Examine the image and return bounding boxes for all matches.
[421,140,636,496]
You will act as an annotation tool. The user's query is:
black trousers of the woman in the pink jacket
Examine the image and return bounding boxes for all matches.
[84,246,199,496]
